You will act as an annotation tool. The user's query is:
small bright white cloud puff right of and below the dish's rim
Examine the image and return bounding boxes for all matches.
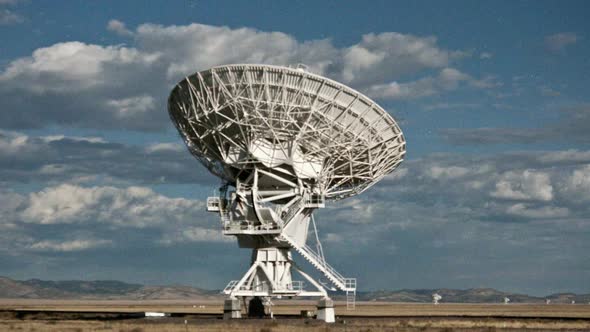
[491,170,553,201]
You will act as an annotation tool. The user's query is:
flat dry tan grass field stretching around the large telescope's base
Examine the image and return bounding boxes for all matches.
[0,300,590,332]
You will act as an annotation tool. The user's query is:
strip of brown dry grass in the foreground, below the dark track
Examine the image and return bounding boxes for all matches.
[0,319,590,332]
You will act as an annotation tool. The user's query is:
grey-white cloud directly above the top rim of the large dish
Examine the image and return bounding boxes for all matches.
[135,23,337,81]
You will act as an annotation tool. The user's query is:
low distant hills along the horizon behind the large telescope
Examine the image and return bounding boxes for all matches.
[0,277,590,303]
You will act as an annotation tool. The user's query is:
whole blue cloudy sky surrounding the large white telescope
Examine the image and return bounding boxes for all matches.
[0,0,590,295]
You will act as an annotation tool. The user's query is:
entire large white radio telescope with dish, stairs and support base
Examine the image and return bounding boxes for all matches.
[168,65,406,321]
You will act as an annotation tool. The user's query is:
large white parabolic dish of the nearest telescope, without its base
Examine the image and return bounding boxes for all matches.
[168,65,406,200]
